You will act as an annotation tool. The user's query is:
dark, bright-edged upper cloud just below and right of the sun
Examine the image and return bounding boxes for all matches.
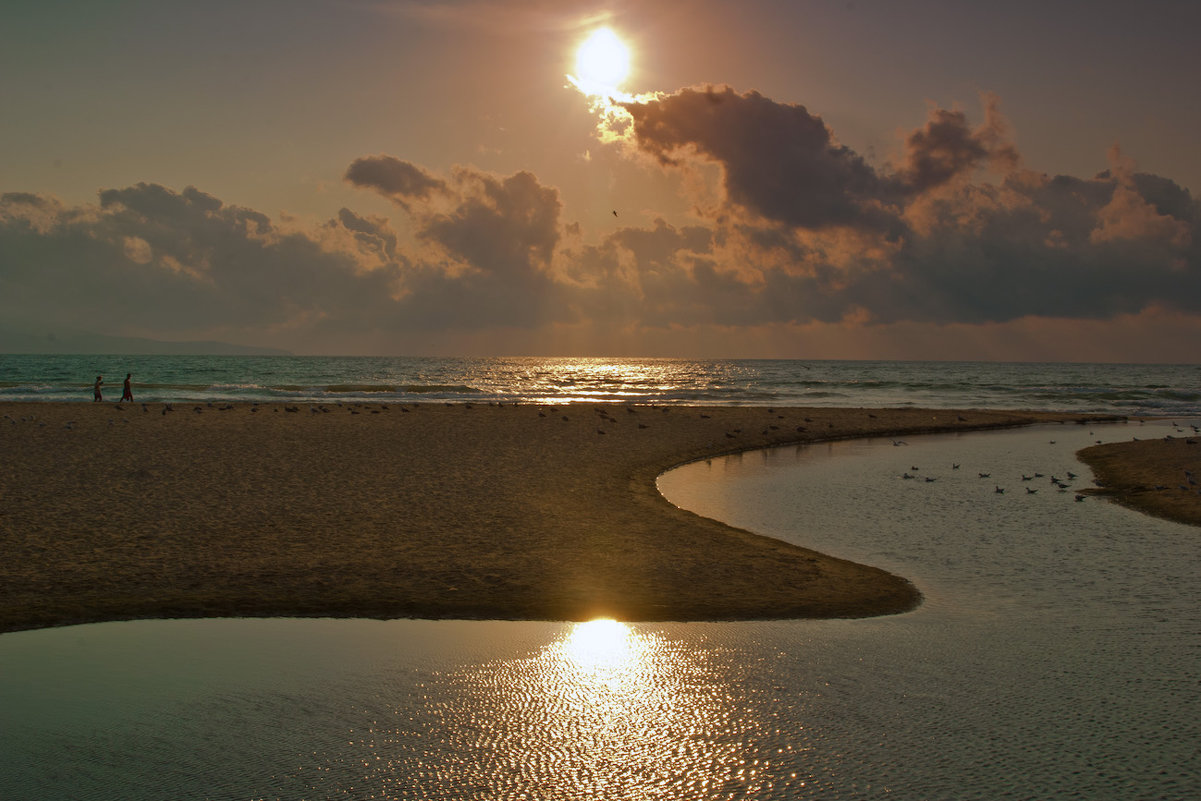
[614,86,1020,233]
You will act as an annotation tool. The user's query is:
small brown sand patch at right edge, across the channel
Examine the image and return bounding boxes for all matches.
[1076,426,1201,526]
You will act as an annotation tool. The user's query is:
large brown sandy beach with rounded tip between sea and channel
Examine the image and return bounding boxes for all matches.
[0,402,1133,630]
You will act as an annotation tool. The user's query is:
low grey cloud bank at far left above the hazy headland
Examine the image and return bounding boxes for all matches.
[0,184,395,341]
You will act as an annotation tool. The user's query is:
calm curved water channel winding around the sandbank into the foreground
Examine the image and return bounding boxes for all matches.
[0,424,1201,800]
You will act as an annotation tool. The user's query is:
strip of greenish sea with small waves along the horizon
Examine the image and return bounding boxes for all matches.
[0,354,1201,417]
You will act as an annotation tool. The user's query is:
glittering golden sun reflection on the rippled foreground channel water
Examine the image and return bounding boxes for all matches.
[389,620,778,799]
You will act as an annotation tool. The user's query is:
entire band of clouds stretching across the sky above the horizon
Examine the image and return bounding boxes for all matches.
[0,88,1201,355]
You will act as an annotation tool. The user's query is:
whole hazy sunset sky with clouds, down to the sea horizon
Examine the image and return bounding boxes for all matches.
[0,0,1201,363]
